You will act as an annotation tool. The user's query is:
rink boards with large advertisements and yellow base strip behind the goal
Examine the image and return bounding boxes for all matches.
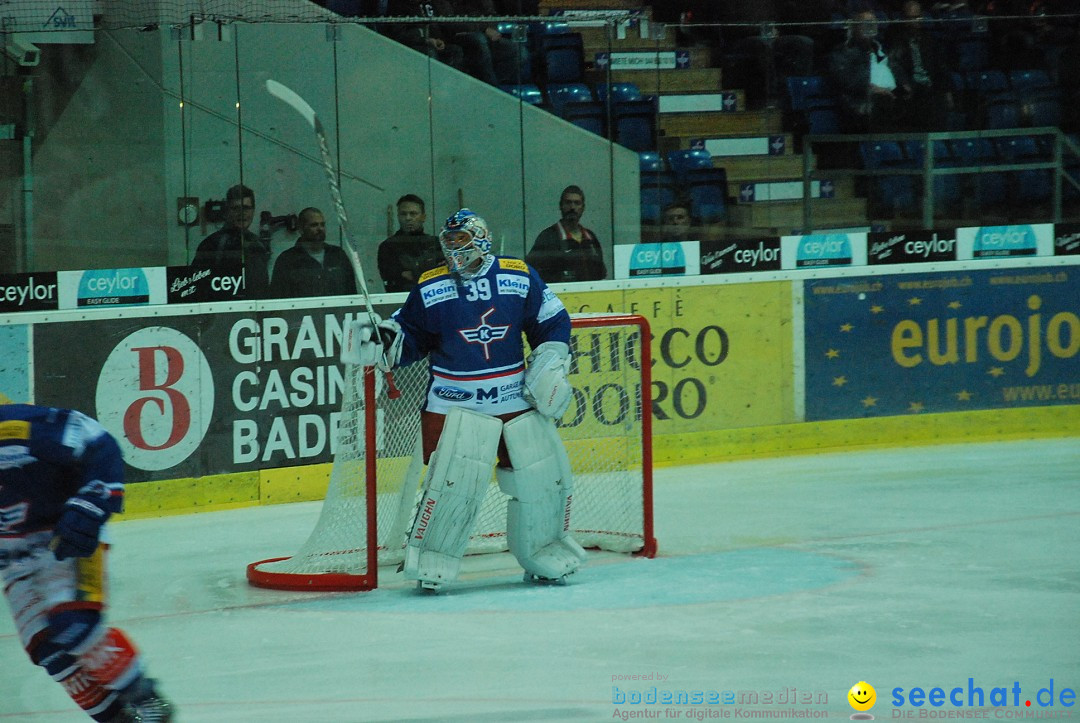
[0,257,1080,514]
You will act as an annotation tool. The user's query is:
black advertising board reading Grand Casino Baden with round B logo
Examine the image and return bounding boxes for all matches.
[33,306,394,482]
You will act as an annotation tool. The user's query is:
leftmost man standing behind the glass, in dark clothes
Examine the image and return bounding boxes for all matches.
[191,184,270,298]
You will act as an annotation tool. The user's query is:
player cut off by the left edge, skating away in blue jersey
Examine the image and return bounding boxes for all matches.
[0,403,172,722]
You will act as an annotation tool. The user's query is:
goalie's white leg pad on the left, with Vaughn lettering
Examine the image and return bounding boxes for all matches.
[402,409,502,589]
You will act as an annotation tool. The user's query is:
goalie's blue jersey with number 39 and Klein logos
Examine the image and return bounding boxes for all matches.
[393,256,570,415]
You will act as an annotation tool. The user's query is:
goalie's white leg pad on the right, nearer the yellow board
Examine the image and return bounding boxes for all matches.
[496,411,585,579]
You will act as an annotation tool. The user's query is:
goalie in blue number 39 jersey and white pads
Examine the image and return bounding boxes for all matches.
[342,209,585,591]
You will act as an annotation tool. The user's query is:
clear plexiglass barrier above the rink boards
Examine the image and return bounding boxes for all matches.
[0,2,1080,289]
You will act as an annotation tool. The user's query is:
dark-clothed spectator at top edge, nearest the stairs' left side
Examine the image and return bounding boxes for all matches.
[453,0,528,85]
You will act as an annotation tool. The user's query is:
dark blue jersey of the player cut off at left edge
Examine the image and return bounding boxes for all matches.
[0,404,124,538]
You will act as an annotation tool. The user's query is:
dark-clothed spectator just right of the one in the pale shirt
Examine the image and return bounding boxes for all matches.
[889,0,953,131]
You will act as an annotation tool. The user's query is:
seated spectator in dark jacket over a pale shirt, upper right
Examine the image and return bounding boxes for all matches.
[828,5,910,133]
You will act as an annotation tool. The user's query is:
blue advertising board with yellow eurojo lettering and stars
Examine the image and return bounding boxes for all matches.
[804,266,1080,420]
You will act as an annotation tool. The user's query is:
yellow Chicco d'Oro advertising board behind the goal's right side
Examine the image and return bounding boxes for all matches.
[559,281,797,461]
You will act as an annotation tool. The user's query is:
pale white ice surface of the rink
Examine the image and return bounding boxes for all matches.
[0,439,1080,722]
